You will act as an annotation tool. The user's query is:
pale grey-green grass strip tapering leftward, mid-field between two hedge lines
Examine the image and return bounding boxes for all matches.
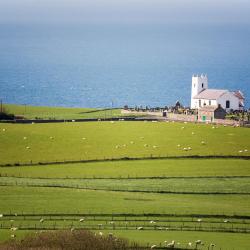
[0,177,250,195]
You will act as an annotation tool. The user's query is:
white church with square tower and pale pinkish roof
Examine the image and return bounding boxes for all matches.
[191,74,244,112]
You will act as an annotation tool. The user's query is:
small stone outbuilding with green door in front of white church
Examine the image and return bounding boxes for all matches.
[197,105,227,122]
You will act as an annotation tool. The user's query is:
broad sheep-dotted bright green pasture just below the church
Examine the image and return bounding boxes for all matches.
[0,122,250,164]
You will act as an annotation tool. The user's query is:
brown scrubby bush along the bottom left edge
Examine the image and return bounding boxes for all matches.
[0,230,145,250]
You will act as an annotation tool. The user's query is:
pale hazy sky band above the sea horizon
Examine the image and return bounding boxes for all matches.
[0,0,250,24]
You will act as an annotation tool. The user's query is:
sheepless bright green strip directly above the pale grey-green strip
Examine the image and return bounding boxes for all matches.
[0,159,250,178]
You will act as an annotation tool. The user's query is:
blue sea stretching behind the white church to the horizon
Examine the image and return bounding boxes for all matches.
[0,25,250,107]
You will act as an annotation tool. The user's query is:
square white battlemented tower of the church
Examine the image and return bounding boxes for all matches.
[191,74,208,109]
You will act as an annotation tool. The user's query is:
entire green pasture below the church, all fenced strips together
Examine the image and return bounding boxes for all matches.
[0,114,250,250]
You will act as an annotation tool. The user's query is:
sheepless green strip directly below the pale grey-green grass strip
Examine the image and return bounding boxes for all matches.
[0,187,250,215]
